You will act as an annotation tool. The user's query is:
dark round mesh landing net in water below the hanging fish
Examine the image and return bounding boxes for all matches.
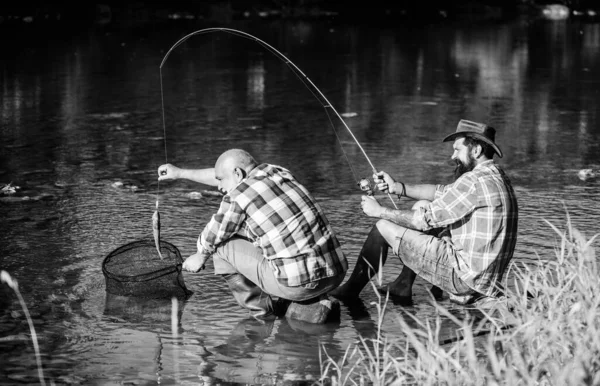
[102,240,192,299]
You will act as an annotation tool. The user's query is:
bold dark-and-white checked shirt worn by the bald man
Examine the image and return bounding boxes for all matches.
[198,164,348,287]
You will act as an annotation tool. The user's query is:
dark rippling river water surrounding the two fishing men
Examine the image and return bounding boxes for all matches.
[0,15,600,385]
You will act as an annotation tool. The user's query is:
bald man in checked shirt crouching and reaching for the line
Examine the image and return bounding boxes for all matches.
[158,149,348,323]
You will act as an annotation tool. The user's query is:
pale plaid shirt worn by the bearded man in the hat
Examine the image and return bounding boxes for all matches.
[415,160,518,296]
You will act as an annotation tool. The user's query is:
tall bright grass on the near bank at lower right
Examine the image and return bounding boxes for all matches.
[318,214,600,386]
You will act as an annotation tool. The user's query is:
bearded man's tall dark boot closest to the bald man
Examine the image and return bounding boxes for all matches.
[329,225,389,300]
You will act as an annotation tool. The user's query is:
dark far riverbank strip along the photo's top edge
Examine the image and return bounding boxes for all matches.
[0,0,598,29]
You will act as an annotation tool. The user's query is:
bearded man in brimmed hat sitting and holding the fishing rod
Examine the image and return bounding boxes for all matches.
[330,120,518,304]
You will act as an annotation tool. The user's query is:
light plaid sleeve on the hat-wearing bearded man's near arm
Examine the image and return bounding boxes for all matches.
[413,173,477,231]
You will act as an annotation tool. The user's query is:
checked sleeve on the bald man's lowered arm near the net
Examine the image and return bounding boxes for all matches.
[197,196,246,254]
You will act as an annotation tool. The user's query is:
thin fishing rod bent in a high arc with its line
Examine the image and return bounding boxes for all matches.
[160,27,398,209]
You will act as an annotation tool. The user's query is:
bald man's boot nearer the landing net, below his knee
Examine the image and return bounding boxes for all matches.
[223,273,274,319]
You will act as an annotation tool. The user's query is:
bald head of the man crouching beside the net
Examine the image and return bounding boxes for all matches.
[215,149,257,193]
